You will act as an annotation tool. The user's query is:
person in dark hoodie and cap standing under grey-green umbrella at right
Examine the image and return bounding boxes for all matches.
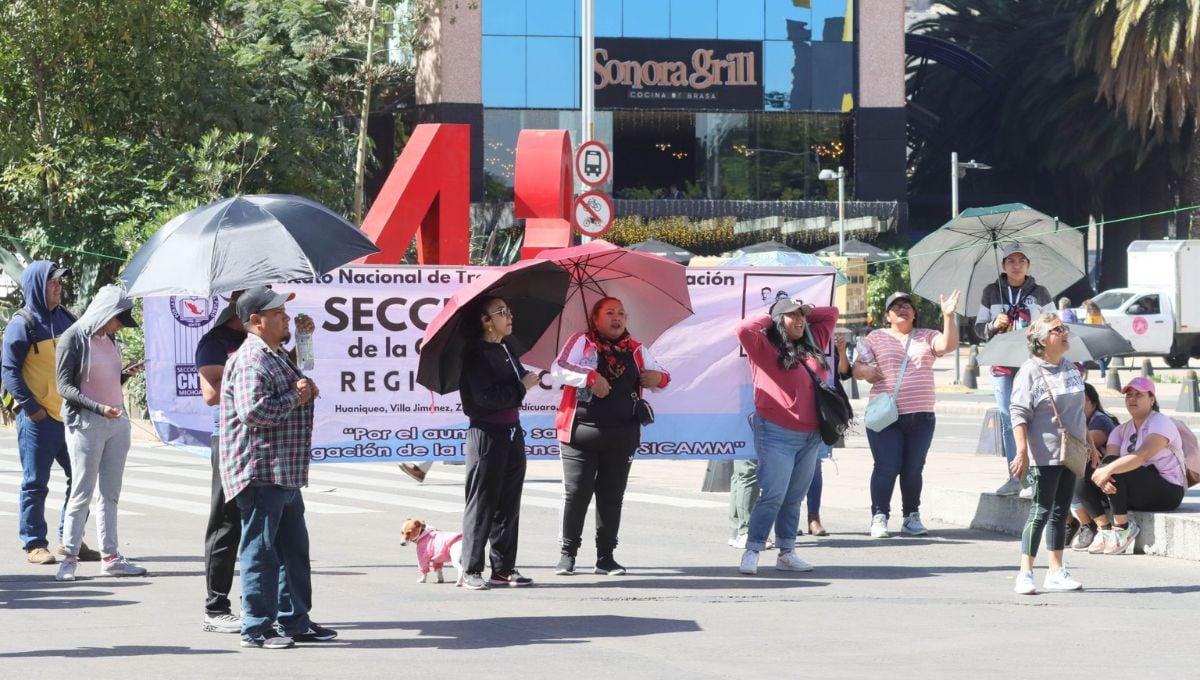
[974,243,1055,495]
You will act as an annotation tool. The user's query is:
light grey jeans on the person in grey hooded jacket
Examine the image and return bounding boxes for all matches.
[62,410,130,558]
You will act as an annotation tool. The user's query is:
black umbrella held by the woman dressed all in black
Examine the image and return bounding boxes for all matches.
[416,260,570,395]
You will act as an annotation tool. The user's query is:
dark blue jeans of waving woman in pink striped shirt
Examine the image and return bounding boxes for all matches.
[866,411,937,517]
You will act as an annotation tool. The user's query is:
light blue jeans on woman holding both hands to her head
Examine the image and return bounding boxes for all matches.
[746,414,822,552]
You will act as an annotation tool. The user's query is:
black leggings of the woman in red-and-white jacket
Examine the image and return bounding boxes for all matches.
[559,422,642,556]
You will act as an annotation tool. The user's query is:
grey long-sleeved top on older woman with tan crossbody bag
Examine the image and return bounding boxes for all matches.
[1008,356,1087,465]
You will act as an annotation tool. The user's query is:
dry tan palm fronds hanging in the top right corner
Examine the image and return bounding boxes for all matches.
[1072,0,1200,236]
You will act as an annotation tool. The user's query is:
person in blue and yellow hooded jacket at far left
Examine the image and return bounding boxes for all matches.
[0,260,100,565]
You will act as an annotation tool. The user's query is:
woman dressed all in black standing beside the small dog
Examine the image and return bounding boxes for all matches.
[458,297,538,590]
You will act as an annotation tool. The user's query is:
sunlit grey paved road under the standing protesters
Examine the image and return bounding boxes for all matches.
[0,434,1200,679]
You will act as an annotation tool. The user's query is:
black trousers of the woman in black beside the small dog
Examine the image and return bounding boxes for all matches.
[462,426,526,576]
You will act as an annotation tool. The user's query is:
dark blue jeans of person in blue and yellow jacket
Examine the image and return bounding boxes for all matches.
[17,409,72,552]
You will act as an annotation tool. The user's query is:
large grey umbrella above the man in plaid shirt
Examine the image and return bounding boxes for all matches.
[121,194,379,297]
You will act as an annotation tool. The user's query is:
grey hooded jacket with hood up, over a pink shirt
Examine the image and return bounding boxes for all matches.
[55,285,133,427]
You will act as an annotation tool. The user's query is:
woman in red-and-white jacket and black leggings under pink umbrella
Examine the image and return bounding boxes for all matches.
[551,297,671,576]
